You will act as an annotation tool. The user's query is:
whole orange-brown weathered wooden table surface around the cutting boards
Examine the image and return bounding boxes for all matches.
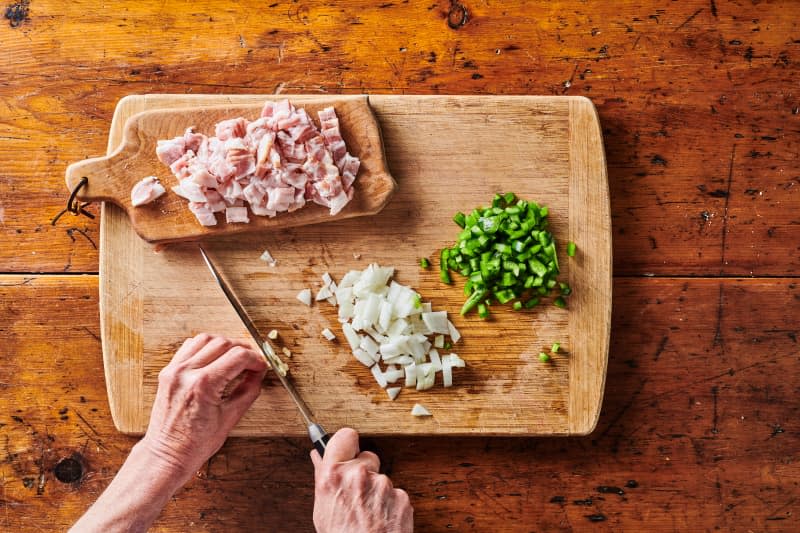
[0,0,800,532]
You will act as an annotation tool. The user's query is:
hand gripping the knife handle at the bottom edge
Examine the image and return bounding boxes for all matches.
[311,428,414,533]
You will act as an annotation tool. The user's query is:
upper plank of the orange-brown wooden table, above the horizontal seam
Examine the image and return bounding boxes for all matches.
[0,0,800,276]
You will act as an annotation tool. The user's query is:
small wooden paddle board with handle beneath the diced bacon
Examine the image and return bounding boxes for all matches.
[66,96,396,243]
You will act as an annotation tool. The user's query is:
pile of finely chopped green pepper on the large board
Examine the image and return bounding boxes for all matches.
[439,192,575,318]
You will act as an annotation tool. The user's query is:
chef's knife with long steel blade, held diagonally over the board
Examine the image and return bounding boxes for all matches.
[199,246,330,456]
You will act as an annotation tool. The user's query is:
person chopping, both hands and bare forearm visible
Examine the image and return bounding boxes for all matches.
[70,334,414,533]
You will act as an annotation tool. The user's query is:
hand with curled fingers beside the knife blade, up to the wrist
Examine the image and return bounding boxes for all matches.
[139,333,268,484]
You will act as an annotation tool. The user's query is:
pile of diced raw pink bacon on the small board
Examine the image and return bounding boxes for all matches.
[156,100,361,226]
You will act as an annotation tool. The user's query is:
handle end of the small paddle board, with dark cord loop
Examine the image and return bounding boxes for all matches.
[66,142,138,207]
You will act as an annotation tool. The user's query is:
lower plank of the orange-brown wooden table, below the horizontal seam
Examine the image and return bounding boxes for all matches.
[0,275,800,532]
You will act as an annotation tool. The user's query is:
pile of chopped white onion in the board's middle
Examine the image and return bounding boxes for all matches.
[316,264,465,400]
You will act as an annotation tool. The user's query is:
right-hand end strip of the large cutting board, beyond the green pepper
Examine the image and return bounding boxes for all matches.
[567,97,612,435]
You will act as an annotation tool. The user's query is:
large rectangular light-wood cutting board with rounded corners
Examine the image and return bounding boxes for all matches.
[100,95,611,436]
